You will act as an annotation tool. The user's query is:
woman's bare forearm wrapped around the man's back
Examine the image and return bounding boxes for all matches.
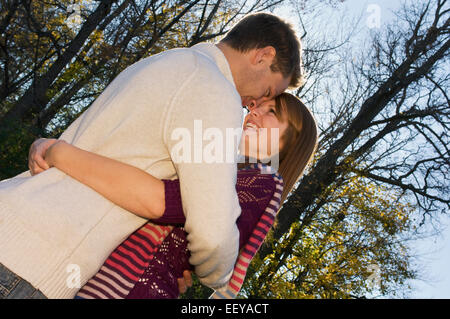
[45,140,165,219]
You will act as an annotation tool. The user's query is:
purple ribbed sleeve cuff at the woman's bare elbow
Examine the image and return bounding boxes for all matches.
[153,179,186,224]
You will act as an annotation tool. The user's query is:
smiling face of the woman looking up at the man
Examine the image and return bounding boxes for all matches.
[240,99,289,160]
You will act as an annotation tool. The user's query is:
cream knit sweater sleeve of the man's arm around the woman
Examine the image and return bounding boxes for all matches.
[163,59,243,289]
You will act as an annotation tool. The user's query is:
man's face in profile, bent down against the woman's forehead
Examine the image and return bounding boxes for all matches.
[238,47,290,105]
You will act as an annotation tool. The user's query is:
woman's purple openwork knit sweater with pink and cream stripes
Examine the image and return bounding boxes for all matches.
[77,164,282,299]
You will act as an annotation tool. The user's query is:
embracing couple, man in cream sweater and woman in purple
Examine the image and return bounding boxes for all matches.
[0,13,317,299]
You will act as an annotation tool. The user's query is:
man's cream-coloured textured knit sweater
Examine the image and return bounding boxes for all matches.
[0,43,242,298]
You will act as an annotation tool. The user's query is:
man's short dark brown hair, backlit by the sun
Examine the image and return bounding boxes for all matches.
[222,13,304,87]
